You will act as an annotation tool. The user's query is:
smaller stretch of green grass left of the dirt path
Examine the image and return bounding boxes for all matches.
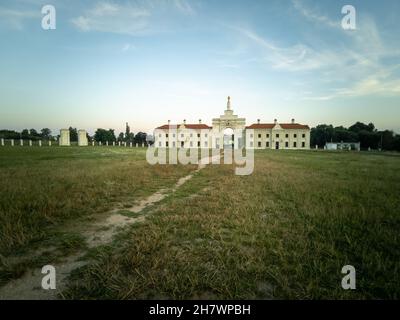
[0,147,193,260]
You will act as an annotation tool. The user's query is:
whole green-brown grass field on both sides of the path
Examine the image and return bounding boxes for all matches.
[0,147,400,299]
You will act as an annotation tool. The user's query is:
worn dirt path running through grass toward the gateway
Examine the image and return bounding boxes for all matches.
[0,156,219,300]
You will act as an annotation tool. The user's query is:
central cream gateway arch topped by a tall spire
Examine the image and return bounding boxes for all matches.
[212,97,246,149]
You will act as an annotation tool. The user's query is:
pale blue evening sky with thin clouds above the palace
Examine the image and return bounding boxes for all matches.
[0,0,400,134]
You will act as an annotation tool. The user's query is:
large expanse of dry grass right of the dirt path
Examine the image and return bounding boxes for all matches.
[64,151,400,299]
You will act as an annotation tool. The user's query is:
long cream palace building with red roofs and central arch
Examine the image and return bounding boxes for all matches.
[154,97,310,149]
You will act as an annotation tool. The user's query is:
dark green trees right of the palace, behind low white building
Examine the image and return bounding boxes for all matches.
[310,122,400,151]
